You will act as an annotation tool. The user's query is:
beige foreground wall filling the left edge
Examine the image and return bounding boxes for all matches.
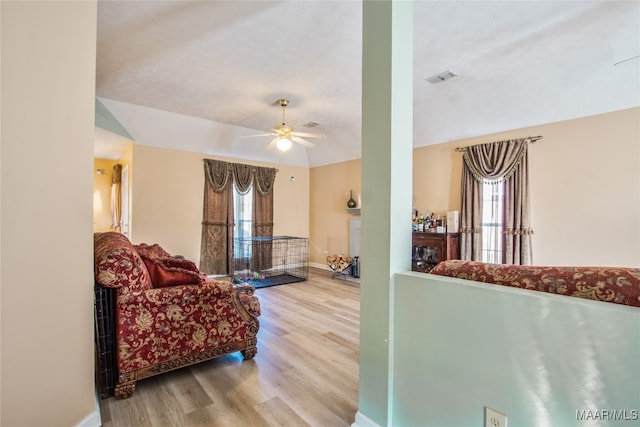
[0,1,98,427]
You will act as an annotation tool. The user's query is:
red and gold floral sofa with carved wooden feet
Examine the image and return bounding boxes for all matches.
[94,232,260,398]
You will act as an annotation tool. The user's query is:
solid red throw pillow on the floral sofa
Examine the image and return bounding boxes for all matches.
[142,257,206,288]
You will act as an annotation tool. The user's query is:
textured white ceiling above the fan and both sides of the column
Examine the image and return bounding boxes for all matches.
[96,1,640,166]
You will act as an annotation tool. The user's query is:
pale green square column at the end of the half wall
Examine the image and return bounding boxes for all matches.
[356,0,413,426]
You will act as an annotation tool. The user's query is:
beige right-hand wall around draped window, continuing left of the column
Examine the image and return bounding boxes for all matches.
[310,108,640,266]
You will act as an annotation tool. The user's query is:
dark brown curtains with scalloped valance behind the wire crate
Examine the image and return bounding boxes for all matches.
[200,159,277,275]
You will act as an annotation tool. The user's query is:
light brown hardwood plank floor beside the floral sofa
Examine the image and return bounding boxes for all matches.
[100,272,360,427]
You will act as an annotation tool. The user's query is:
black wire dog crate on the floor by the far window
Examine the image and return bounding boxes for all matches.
[233,236,309,288]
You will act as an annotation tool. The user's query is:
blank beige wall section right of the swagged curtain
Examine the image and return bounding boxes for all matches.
[529,108,640,267]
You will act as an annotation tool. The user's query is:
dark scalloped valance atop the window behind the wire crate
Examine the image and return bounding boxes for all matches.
[204,159,277,195]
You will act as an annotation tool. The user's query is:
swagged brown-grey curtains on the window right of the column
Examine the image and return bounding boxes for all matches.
[460,138,533,265]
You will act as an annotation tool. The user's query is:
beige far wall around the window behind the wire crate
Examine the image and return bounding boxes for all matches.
[131,144,309,263]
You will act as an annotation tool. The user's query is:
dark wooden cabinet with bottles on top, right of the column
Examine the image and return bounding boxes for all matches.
[411,231,460,273]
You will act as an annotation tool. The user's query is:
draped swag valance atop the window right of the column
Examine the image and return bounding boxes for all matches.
[462,139,529,183]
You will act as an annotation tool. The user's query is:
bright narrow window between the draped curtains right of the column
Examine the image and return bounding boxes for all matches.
[482,182,504,264]
